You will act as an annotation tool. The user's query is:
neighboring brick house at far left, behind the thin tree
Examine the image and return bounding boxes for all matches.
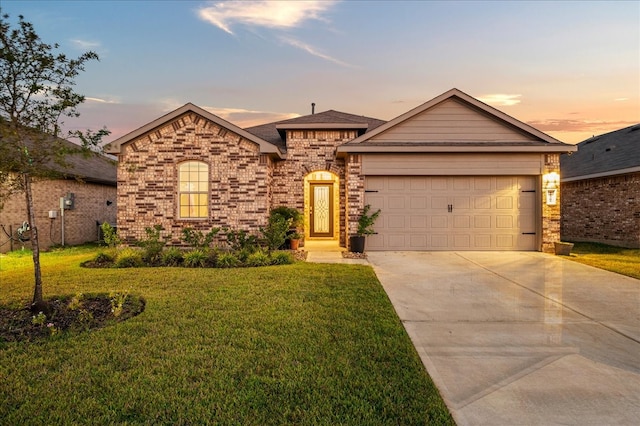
[0,142,117,252]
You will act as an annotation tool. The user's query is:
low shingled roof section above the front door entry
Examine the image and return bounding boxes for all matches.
[245,109,385,150]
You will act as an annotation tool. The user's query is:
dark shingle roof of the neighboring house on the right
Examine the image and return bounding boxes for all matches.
[560,124,640,182]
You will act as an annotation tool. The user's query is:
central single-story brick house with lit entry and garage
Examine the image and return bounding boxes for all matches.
[109,89,575,251]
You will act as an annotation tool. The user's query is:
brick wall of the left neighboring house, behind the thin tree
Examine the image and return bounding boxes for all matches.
[0,179,116,252]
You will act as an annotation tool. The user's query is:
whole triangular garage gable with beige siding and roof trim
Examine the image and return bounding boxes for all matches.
[338,88,575,154]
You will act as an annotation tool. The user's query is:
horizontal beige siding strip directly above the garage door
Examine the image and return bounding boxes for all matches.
[362,153,544,176]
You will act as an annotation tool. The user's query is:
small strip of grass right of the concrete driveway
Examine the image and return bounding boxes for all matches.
[567,243,640,279]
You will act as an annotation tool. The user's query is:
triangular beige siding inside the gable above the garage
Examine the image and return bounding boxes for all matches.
[370,99,536,142]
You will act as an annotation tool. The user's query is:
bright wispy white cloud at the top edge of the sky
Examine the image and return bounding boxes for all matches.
[197,0,336,34]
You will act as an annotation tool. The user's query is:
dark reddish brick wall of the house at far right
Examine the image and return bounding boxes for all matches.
[561,173,640,248]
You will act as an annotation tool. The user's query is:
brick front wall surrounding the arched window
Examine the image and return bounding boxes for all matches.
[118,113,272,245]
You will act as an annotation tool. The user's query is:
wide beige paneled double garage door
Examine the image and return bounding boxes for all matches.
[365,176,537,250]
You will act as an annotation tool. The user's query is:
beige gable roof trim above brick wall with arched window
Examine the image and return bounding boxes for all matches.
[105,103,281,157]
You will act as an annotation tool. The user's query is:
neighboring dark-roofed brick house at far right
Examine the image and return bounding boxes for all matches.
[561,124,640,248]
